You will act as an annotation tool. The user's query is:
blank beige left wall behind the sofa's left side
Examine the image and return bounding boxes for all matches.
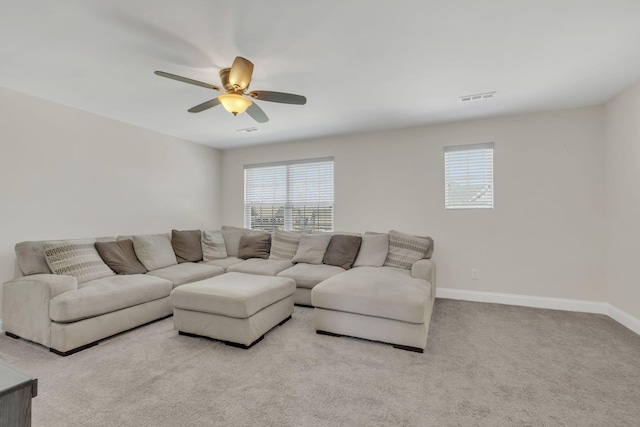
[0,88,221,318]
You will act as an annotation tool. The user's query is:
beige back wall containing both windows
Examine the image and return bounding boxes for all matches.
[222,107,606,301]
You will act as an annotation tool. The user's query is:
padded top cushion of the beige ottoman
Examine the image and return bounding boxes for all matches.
[171,273,296,319]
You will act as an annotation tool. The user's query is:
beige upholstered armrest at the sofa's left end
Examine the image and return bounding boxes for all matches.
[2,274,78,347]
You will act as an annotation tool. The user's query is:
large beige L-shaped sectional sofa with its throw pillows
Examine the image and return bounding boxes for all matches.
[3,226,435,355]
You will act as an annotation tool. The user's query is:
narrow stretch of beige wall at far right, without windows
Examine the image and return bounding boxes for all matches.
[605,83,640,319]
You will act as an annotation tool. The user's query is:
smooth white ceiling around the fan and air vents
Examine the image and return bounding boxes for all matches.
[0,0,640,149]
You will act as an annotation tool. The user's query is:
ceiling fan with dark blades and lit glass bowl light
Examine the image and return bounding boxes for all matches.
[155,56,307,123]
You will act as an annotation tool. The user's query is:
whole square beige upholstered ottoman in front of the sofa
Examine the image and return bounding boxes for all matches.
[171,273,296,348]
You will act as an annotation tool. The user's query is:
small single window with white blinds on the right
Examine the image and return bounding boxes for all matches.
[444,142,493,209]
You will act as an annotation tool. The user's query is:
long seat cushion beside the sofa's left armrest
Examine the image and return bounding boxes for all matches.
[49,274,173,323]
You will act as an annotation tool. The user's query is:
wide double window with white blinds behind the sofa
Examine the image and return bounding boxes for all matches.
[244,157,333,231]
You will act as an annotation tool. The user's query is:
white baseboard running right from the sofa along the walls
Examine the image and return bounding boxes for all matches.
[436,288,640,335]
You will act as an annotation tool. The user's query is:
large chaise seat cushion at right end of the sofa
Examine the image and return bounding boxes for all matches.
[311,267,431,323]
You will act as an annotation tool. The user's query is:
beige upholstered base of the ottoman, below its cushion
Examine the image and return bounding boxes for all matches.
[173,295,293,348]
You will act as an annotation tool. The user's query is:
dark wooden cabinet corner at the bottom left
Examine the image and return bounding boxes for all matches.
[0,362,38,427]
